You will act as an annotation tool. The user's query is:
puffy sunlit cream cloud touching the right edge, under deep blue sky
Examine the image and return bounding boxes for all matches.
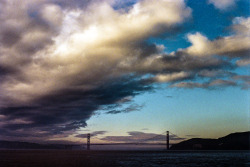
[180,17,250,57]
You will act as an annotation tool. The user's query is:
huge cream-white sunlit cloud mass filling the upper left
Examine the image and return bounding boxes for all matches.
[0,0,191,103]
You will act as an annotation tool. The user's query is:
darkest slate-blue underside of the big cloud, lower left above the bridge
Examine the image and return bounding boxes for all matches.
[0,77,152,140]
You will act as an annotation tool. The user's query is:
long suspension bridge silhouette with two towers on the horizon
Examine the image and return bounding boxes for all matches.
[86,131,184,150]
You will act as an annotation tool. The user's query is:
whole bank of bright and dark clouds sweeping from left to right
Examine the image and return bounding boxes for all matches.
[0,0,250,140]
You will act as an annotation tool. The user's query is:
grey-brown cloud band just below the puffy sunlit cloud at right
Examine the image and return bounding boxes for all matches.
[127,52,235,74]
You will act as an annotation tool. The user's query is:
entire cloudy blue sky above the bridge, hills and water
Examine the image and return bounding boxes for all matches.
[0,0,250,143]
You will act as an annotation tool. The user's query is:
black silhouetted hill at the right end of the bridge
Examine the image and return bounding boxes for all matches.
[170,132,250,150]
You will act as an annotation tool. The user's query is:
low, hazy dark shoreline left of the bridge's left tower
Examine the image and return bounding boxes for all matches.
[0,141,80,149]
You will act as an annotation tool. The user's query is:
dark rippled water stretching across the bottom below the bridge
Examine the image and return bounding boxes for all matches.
[0,150,250,167]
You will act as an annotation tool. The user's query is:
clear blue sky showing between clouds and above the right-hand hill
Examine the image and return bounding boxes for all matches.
[79,0,250,144]
